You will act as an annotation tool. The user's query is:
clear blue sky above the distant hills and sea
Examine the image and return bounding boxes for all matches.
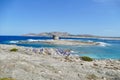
[0,0,120,36]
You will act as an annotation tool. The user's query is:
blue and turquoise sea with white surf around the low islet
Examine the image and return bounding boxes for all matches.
[0,36,120,59]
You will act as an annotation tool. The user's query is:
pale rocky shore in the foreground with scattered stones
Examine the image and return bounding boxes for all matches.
[0,44,120,80]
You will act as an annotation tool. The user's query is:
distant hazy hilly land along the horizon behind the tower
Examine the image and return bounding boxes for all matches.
[22,31,120,40]
